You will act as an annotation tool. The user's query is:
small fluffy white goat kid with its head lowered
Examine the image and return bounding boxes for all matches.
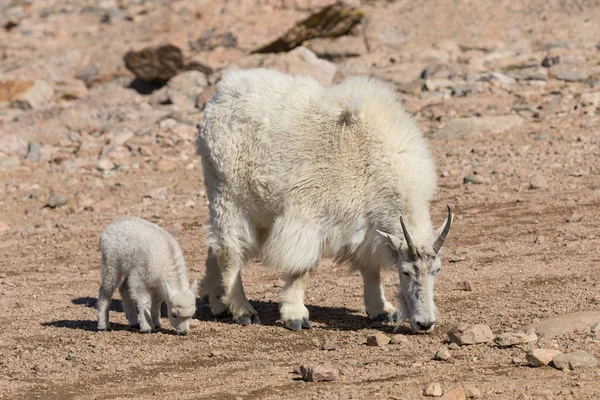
[98,217,198,335]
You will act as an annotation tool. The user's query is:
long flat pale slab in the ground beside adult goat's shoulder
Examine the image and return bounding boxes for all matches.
[433,115,524,139]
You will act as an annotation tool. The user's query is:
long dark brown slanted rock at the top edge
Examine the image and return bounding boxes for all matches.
[253,1,364,53]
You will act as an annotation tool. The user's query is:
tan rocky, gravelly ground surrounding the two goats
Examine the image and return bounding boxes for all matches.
[0,0,600,400]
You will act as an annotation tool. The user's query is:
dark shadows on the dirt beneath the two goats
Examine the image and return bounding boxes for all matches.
[52,297,398,333]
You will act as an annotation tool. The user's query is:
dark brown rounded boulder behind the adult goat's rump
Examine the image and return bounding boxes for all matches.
[124,44,184,83]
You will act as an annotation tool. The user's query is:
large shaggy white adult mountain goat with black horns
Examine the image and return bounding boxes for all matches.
[198,69,452,332]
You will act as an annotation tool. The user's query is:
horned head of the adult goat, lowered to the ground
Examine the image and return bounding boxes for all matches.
[378,206,453,333]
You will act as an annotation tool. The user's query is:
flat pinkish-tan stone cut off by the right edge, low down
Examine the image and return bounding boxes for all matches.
[525,311,600,338]
